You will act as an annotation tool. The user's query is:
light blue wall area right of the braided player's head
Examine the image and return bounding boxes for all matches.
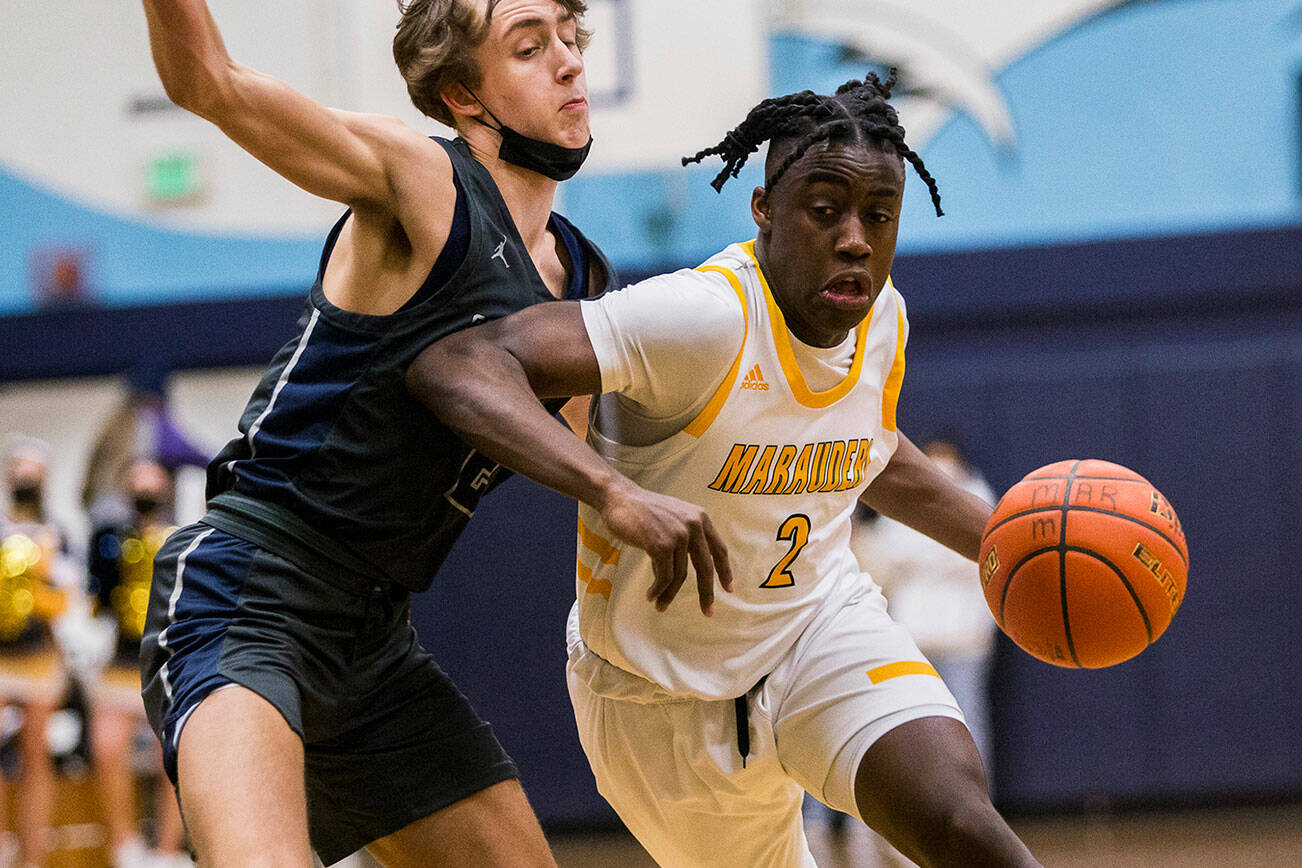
[902,0,1302,250]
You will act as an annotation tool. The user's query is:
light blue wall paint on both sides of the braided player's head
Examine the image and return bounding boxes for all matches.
[568,0,1302,267]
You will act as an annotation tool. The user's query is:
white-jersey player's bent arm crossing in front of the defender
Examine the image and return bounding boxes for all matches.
[408,302,732,614]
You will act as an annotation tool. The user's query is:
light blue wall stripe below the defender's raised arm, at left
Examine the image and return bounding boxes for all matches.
[0,165,322,312]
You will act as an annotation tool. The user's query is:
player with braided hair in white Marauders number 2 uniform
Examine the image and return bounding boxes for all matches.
[415,74,1038,868]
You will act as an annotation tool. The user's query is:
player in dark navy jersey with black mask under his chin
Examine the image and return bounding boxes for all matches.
[141,0,725,868]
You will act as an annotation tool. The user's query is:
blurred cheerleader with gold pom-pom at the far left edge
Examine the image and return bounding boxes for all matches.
[0,435,81,865]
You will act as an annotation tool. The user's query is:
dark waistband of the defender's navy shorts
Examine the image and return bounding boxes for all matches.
[199,492,393,593]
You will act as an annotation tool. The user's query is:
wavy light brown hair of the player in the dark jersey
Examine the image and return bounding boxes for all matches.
[393,0,591,126]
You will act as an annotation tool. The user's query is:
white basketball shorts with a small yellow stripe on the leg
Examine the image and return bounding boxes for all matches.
[566,576,962,868]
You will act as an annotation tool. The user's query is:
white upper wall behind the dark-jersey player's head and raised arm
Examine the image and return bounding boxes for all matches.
[0,0,767,236]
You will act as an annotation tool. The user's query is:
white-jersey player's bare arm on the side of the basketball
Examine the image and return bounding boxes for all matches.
[859,432,993,561]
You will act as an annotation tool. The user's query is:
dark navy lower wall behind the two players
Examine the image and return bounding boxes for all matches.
[0,230,1302,825]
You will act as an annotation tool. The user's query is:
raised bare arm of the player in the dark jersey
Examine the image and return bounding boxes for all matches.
[145,0,453,217]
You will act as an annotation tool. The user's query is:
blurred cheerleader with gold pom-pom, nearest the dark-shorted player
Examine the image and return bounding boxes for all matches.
[87,459,190,868]
